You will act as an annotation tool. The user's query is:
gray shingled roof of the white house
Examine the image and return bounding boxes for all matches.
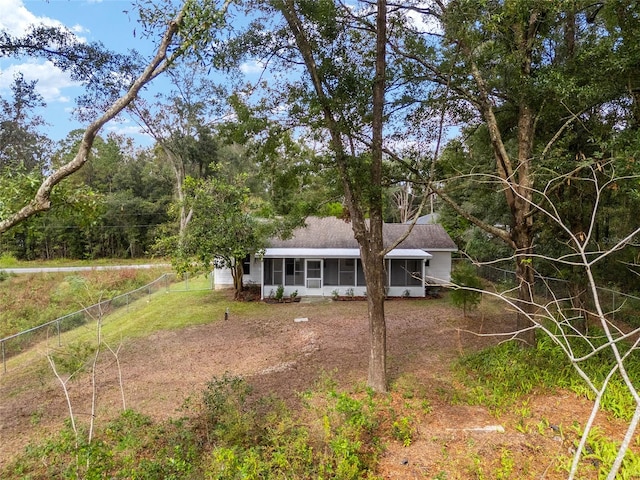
[269,217,457,251]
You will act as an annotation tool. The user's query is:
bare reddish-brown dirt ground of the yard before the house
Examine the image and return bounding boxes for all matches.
[0,292,618,479]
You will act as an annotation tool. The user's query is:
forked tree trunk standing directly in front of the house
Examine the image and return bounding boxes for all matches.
[278,0,387,392]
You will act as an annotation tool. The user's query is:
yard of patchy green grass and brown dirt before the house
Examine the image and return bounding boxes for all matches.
[0,280,640,480]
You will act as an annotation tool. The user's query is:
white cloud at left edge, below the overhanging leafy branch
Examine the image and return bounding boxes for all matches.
[0,61,80,103]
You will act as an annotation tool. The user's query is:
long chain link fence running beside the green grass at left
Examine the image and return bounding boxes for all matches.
[0,273,213,373]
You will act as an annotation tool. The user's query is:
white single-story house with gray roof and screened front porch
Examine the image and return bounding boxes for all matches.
[214,217,457,298]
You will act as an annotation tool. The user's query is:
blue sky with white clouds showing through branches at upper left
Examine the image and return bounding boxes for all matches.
[0,0,179,144]
